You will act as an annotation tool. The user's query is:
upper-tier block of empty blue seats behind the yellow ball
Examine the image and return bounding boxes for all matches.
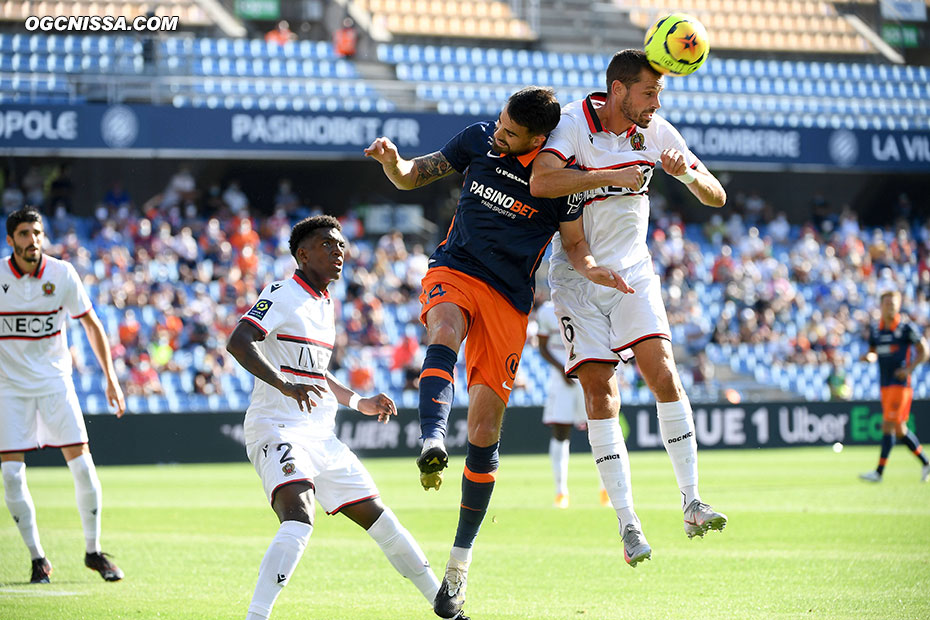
[378,44,930,129]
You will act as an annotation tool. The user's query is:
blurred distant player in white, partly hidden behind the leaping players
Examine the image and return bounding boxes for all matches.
[536,300,610,508]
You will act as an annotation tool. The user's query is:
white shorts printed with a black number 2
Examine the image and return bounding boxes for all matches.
[245,423,379,515]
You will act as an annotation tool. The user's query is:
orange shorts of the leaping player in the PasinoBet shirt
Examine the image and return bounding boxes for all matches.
[420,267,529,405]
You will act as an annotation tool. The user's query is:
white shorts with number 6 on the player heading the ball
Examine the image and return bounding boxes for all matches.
[549,258,671,375]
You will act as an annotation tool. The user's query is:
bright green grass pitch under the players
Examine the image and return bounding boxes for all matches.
[0,447,930,620]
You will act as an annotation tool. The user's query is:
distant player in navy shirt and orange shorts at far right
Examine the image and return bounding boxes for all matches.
[859,290,930,482]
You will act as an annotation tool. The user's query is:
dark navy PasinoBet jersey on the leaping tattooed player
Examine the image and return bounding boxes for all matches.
[429,122,581,313]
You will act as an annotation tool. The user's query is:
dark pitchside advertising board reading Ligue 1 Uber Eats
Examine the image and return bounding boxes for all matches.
[29,401,930,465]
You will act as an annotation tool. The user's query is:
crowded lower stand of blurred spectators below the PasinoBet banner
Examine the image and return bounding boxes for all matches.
[6,162,930,413]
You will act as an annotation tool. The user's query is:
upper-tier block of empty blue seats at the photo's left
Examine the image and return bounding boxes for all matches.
[0,34,395,112]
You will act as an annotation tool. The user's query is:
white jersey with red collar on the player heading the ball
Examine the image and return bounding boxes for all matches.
[542,93,698,277]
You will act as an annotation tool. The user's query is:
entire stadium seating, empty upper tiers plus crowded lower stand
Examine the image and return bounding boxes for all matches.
[0,0,930,413]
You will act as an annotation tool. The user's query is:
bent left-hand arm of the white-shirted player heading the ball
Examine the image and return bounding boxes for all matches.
[530,153,645,198]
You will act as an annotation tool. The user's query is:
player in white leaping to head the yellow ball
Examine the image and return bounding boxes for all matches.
[530,49,726,567]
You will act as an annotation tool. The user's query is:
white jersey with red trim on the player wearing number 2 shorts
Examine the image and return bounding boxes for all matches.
[240,272,339,437]
